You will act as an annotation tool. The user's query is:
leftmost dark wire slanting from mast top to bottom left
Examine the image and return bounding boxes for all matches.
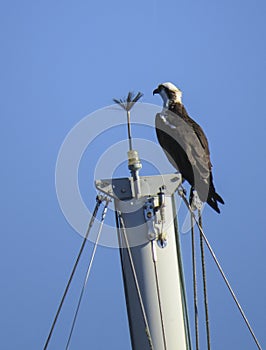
[43,195,103,350]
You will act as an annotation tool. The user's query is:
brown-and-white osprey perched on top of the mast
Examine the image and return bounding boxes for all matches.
[153,83,224,213]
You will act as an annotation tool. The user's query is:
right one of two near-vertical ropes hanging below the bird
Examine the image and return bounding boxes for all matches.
[198,210,211,350]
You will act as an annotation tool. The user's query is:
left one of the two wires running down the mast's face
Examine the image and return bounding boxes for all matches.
[117,213,154,350]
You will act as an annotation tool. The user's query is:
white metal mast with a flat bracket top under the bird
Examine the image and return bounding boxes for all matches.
[96,174,190,350]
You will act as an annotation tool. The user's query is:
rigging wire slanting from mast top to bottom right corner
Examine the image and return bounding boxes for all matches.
[178,189,262,350]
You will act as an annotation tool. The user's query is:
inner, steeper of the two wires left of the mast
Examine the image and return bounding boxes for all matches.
[66,199,110,350]
